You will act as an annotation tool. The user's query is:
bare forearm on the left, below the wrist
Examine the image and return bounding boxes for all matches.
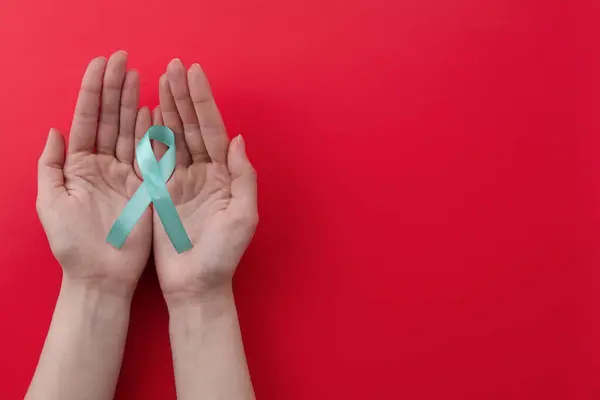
[26,278,131,400]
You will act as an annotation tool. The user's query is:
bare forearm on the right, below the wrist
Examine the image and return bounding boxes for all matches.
[169,288,254,400]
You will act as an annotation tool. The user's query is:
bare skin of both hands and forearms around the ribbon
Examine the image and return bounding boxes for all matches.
[26,51,258,399]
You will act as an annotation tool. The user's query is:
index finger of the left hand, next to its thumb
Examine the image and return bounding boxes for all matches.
[68,57,106,154]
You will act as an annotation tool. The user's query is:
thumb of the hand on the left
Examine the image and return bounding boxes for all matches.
[38,129,65,199]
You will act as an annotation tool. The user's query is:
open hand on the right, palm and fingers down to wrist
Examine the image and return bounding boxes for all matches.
[154,59,258,299]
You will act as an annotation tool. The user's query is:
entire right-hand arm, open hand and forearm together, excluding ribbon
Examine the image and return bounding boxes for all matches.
[154,59,258,399]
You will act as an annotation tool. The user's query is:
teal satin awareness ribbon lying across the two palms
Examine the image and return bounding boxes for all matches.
[106,126,192,254]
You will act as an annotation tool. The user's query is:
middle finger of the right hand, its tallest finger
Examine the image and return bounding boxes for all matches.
[167,58,210,162]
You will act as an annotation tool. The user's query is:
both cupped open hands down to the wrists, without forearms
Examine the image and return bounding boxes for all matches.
[37,51,258,304]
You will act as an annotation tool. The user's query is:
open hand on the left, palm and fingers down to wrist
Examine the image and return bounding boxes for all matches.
[37,52,152,291]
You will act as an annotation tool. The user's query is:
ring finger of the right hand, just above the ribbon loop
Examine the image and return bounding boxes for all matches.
[158,74,191,167]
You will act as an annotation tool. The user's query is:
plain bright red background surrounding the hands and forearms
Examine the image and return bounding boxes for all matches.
[0,0,600,400]
